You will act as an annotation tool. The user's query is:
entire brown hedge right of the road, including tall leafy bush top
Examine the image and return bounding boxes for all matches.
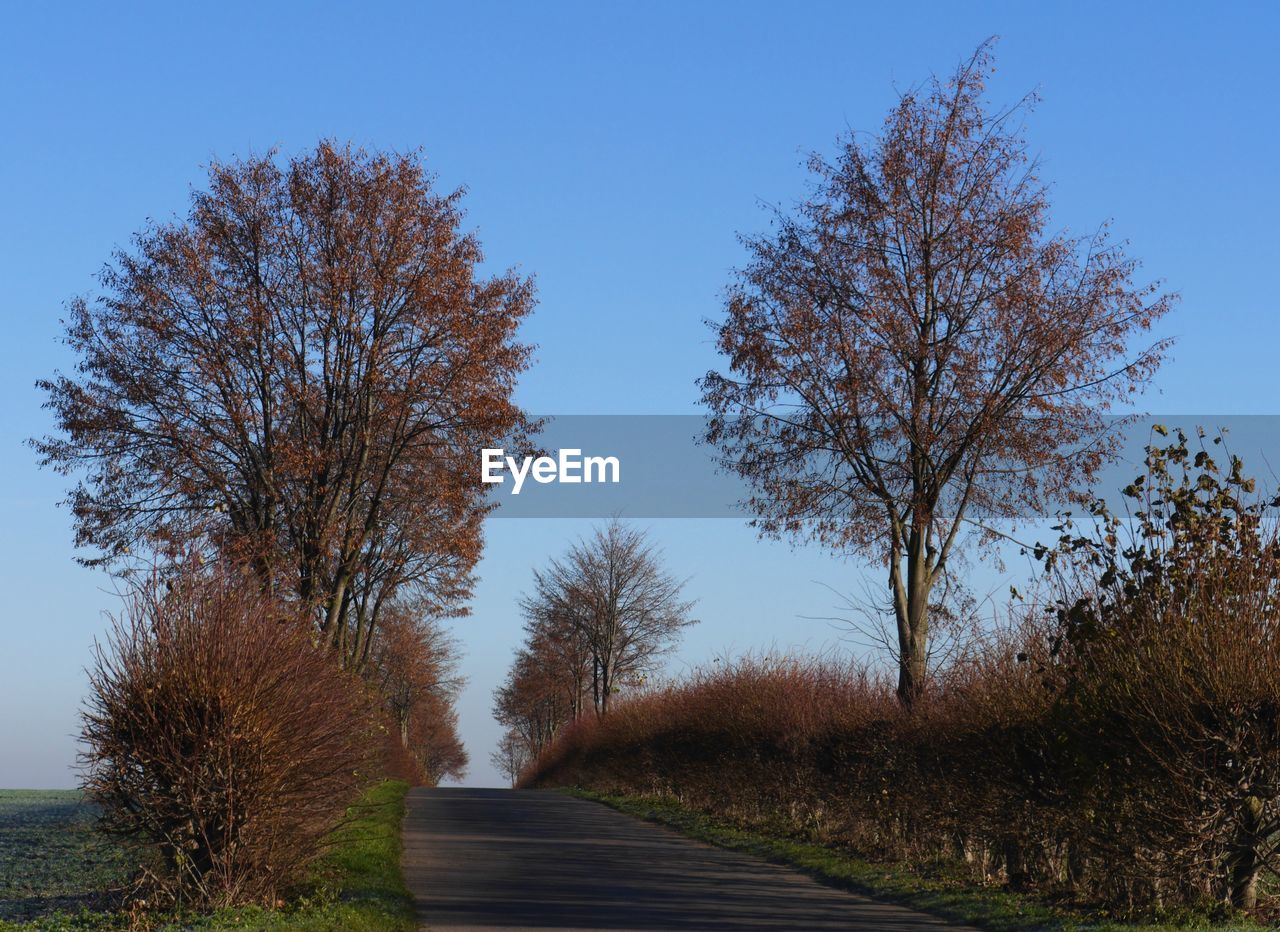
[525,430,1280,909]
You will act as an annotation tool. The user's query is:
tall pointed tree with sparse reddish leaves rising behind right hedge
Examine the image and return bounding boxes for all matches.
[700,44,1172,704]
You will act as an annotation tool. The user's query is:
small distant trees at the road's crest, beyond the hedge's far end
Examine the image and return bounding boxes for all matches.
[493,518,695,782]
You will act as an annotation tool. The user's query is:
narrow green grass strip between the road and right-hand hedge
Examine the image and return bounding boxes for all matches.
[563,787,1261,932]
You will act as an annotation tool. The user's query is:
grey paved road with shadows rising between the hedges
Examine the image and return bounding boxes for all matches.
[404,789,957,932]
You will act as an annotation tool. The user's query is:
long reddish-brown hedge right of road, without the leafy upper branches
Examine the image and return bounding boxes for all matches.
[522,611,1280,909]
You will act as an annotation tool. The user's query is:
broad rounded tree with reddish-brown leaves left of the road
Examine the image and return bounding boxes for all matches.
[36,143,534,667]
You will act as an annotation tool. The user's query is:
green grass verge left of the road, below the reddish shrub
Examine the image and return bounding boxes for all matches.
[0,781,417,932]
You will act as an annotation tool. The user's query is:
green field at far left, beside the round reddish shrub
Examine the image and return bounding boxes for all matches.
[0,790,127,922]
